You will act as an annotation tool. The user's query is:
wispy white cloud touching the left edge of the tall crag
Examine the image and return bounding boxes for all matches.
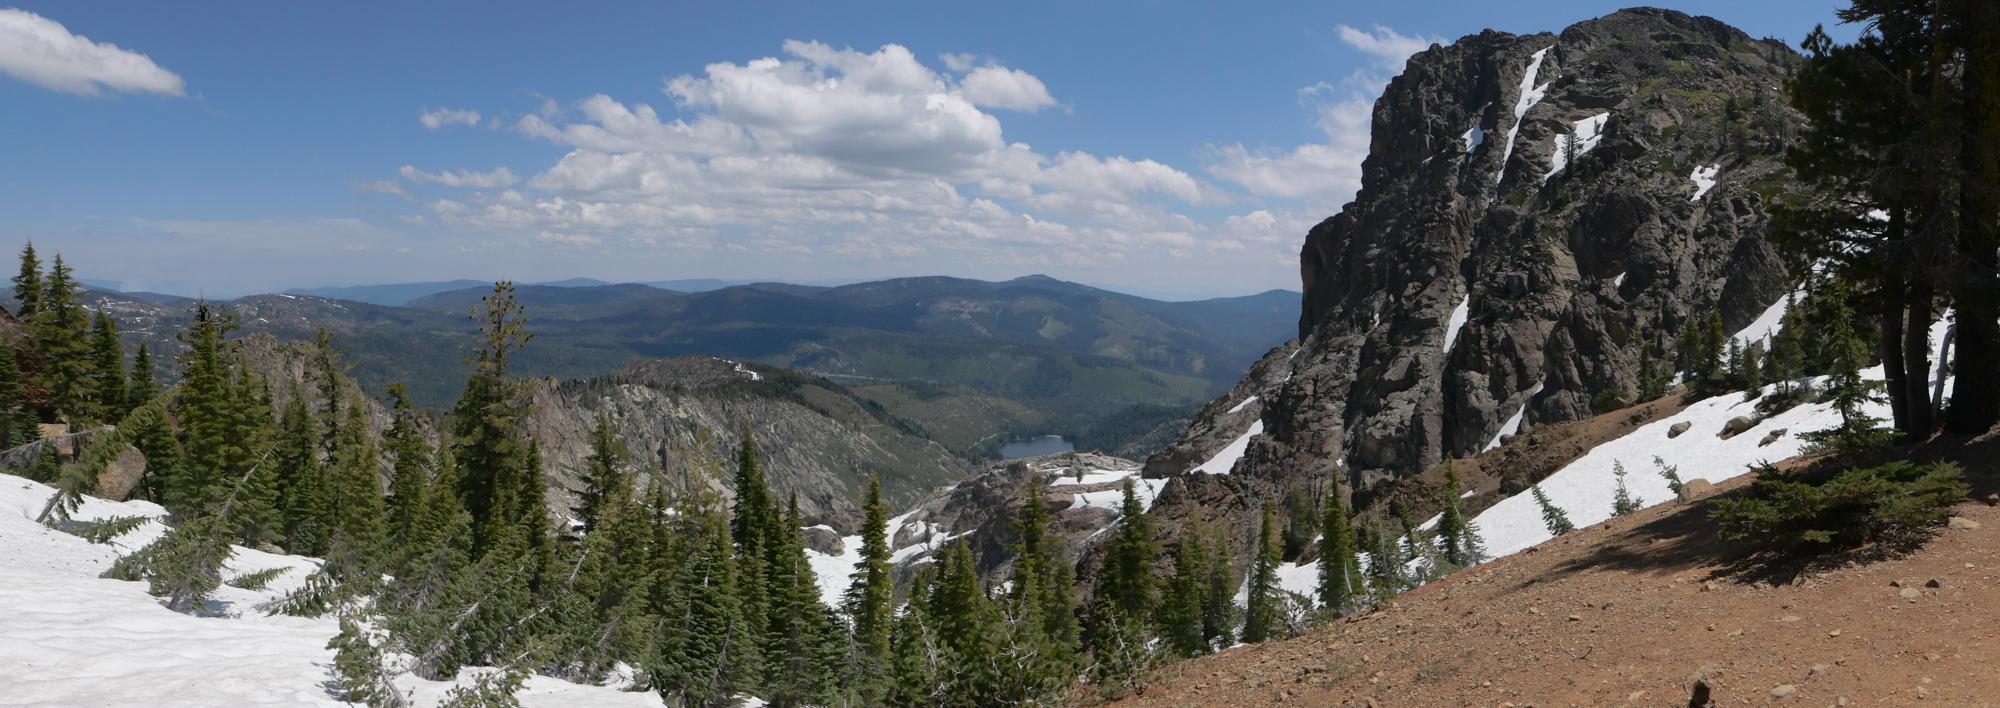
[1206,24,1440,210]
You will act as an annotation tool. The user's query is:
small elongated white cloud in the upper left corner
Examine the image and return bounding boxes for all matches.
[0,8,186,96]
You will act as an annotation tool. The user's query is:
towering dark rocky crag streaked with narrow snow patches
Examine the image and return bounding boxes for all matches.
[1148,8,1798,504]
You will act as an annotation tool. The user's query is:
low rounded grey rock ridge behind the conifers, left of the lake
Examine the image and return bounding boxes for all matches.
[526,356,972,532]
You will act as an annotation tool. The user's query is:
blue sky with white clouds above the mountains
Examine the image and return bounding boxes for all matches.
[0,0,1854,298]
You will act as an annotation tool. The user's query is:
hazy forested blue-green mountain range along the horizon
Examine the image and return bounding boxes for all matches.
[50,276,1300,458]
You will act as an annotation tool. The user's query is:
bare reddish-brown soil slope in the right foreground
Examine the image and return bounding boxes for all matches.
[1130,440,2000,706]
